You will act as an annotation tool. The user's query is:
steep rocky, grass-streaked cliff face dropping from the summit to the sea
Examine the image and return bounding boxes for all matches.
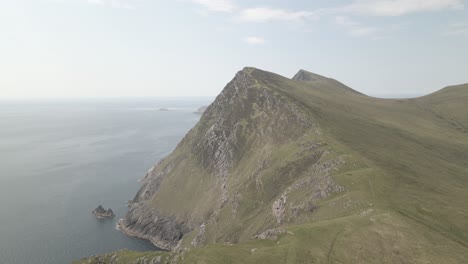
[119,68,345,250]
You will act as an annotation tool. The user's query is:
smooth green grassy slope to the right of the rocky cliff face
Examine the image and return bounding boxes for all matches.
[75,70,468,263]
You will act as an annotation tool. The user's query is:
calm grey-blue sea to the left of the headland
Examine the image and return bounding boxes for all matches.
[0,98,210,264]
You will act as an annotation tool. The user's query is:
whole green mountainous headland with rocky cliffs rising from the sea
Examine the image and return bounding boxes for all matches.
[76,68,468,263]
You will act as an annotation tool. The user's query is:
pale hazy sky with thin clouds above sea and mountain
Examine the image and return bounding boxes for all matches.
[0,0,468,99]
